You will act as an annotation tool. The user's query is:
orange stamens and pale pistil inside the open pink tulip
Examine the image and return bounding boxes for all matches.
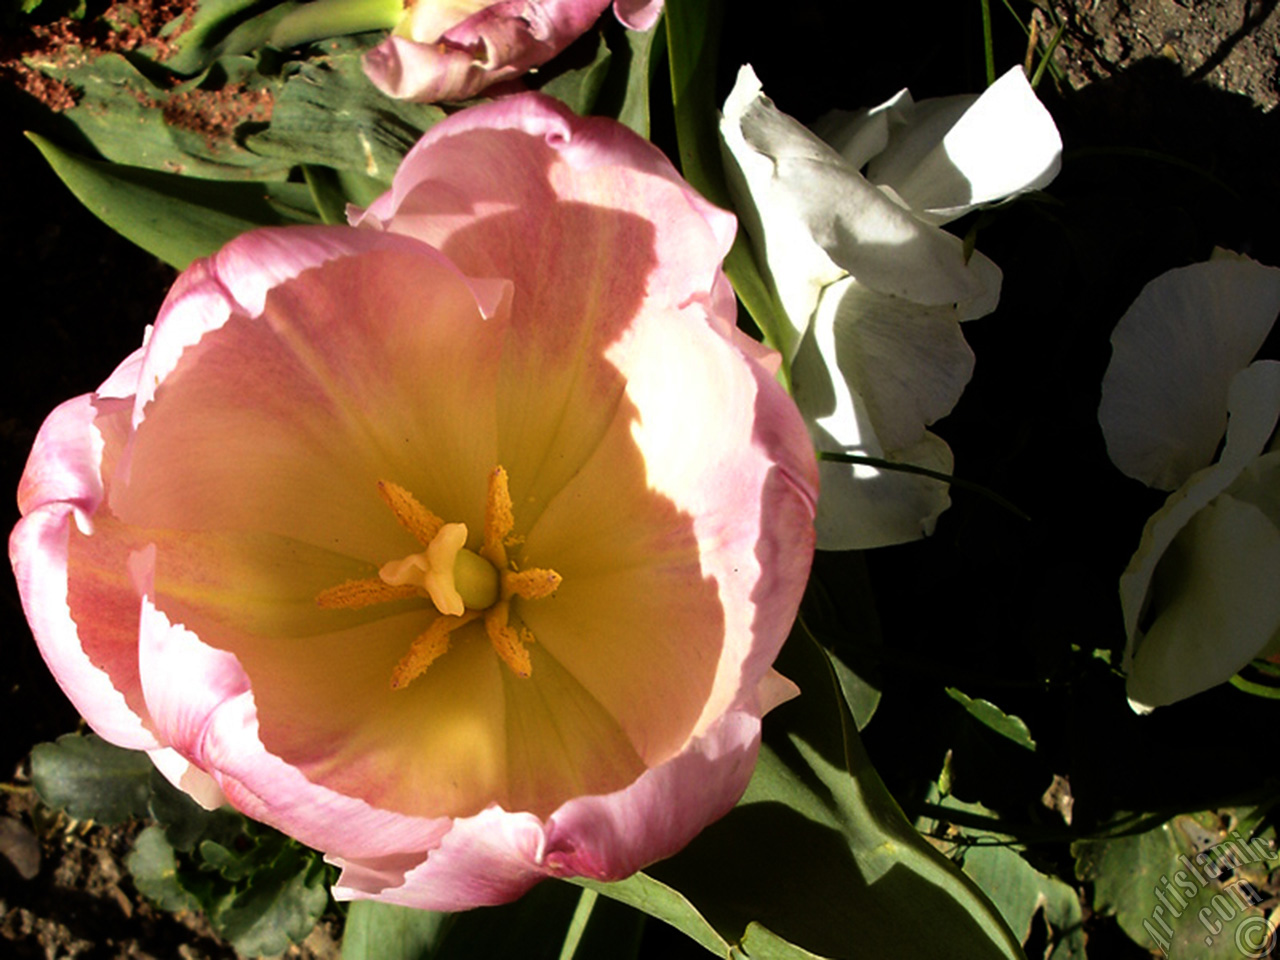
[316,467,561,690]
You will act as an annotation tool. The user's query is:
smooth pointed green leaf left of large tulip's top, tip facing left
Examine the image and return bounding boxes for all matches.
[27,133,319,269]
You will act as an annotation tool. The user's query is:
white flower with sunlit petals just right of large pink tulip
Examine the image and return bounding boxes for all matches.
[721,67,1062,549]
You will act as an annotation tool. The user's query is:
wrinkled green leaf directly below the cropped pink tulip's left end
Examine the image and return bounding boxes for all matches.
[246,51,444,185]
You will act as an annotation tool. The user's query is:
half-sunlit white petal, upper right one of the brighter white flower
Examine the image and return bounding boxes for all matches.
[867,67,1062,223]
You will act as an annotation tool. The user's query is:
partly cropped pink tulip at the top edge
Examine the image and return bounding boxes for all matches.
[365,0,662,102]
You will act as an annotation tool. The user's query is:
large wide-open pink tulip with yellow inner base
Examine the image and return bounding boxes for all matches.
[10,93,817,910]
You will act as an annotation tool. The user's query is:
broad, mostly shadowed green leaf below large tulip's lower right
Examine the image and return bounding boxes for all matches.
[640,632,1023,960]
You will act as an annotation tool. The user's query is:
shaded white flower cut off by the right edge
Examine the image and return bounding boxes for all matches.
[1098,251,1280,713]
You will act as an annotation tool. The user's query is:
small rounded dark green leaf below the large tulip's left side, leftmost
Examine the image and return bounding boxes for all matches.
[31,733,154,823]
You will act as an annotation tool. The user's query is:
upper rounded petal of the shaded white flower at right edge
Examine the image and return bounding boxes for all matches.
[1098,259,1280,490]
